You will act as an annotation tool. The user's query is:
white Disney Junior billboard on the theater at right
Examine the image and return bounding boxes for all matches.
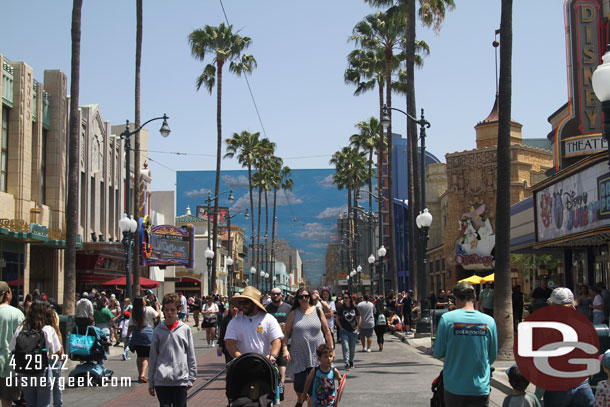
[535,160,610,242]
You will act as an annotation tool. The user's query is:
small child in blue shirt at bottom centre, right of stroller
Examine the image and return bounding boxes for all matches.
[304,343,341,407]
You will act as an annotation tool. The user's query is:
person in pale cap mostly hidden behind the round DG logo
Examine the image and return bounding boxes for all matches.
[536,287,594,407]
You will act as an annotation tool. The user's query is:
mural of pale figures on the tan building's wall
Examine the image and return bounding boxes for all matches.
[455,202,496,270]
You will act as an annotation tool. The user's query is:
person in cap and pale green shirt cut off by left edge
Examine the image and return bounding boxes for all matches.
[0,281,25,407]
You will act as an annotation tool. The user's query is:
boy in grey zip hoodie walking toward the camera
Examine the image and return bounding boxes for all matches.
[148,294,197,406]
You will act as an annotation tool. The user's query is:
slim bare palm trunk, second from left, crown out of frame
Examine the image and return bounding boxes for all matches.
[133,0,142,293]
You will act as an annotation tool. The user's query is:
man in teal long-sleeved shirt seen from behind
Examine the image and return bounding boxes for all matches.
[434,282,498,407]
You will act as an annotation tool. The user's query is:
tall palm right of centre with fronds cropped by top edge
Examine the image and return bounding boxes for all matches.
[364,0,455,298]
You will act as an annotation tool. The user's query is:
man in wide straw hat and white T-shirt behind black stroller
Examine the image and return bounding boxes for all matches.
[225,286,284,361]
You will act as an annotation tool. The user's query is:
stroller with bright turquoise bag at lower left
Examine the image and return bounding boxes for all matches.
[69,325,114,386]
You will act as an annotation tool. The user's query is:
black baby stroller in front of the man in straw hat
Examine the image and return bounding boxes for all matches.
[226,353,279,407]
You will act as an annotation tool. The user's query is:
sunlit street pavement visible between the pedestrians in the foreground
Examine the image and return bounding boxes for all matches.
[50,322,512,407]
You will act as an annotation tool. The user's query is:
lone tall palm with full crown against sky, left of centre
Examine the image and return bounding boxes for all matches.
[189,23,256,291]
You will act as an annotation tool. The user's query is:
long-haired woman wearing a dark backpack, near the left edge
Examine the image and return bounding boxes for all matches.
[9,301,62,407]
